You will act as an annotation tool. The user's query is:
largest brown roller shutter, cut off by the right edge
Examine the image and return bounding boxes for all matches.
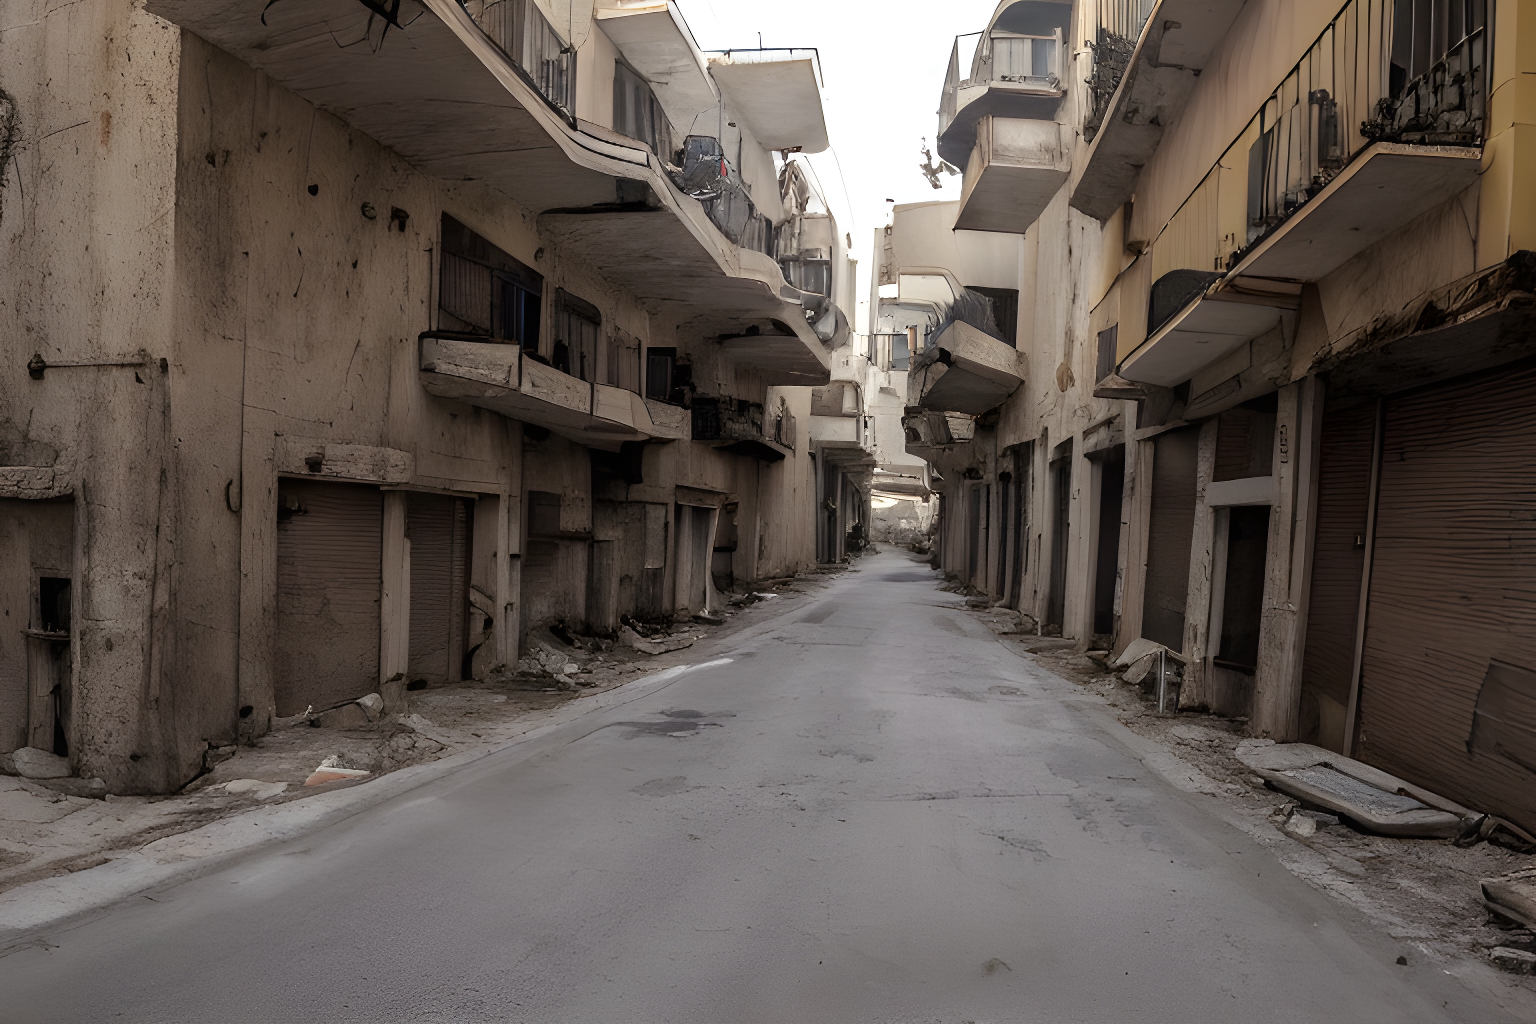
[1356,360,1536,829]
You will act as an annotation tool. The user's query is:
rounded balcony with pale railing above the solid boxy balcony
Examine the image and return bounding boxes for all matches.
[938,0,1072,166]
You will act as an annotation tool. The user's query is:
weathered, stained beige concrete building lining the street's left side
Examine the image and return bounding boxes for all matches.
[0,0,851,792]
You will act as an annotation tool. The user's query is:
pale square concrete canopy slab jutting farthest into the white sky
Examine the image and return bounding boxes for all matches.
[710,51,829,154]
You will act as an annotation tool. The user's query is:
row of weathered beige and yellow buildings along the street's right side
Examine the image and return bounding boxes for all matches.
[891,0,1536,827]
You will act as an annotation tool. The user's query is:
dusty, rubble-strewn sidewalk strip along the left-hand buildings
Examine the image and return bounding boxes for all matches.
[0,567,843,892]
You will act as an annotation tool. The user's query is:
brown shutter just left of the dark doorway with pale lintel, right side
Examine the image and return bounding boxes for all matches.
[1141,427,1200,651]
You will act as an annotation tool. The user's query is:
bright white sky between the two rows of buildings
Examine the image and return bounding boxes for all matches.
[677,0,997,329]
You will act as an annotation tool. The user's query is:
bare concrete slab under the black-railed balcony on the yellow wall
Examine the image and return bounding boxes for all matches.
[1233,143,1482,281]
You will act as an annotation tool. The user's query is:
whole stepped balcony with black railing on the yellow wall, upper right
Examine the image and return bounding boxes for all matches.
[1120,0,1487,387]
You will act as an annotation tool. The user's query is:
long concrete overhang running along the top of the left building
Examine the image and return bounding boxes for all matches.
[146,0,826,382]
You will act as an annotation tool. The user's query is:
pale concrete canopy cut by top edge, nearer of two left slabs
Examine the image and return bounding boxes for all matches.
[598,0,717,127]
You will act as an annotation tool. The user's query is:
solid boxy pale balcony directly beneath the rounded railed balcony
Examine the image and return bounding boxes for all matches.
[955,115,1074,235]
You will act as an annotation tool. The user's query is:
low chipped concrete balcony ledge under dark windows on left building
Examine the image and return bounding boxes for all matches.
[419,333,690,451]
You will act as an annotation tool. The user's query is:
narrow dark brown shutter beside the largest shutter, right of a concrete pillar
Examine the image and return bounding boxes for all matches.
[1301,402,1376,749]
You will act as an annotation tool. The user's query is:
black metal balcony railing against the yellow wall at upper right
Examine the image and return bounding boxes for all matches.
[1247,0,1487,244]
